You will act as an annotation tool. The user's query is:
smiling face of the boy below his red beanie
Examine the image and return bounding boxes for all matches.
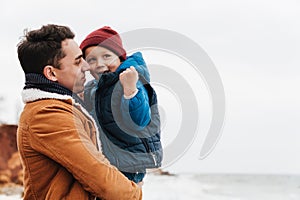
[85,46,121,79]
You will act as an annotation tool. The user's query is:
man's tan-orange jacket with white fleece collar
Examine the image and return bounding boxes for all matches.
[17,89,142,200]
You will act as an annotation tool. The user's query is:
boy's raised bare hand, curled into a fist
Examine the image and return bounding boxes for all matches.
[119,66,139,96]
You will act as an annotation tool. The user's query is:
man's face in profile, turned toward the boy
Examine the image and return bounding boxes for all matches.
[54,39,89,94]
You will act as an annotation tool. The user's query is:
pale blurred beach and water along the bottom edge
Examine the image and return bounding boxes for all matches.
[0,173,300,200]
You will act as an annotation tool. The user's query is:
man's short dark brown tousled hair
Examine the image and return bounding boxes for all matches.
[18,24,75,74]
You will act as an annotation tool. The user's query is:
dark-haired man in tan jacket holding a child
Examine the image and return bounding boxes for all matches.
[18,25,142,200]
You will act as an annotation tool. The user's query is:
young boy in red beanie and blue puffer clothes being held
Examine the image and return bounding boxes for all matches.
[80,26,162,183]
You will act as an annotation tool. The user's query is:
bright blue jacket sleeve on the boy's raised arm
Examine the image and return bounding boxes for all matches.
[121,84,151,130]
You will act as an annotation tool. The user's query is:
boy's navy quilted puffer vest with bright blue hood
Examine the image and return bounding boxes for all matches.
[95,52,163,173]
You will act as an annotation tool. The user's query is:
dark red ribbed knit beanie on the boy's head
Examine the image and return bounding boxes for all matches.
[80,26,126,61]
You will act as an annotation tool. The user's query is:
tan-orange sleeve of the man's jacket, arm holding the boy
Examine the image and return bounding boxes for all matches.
[30,105,142,200]
